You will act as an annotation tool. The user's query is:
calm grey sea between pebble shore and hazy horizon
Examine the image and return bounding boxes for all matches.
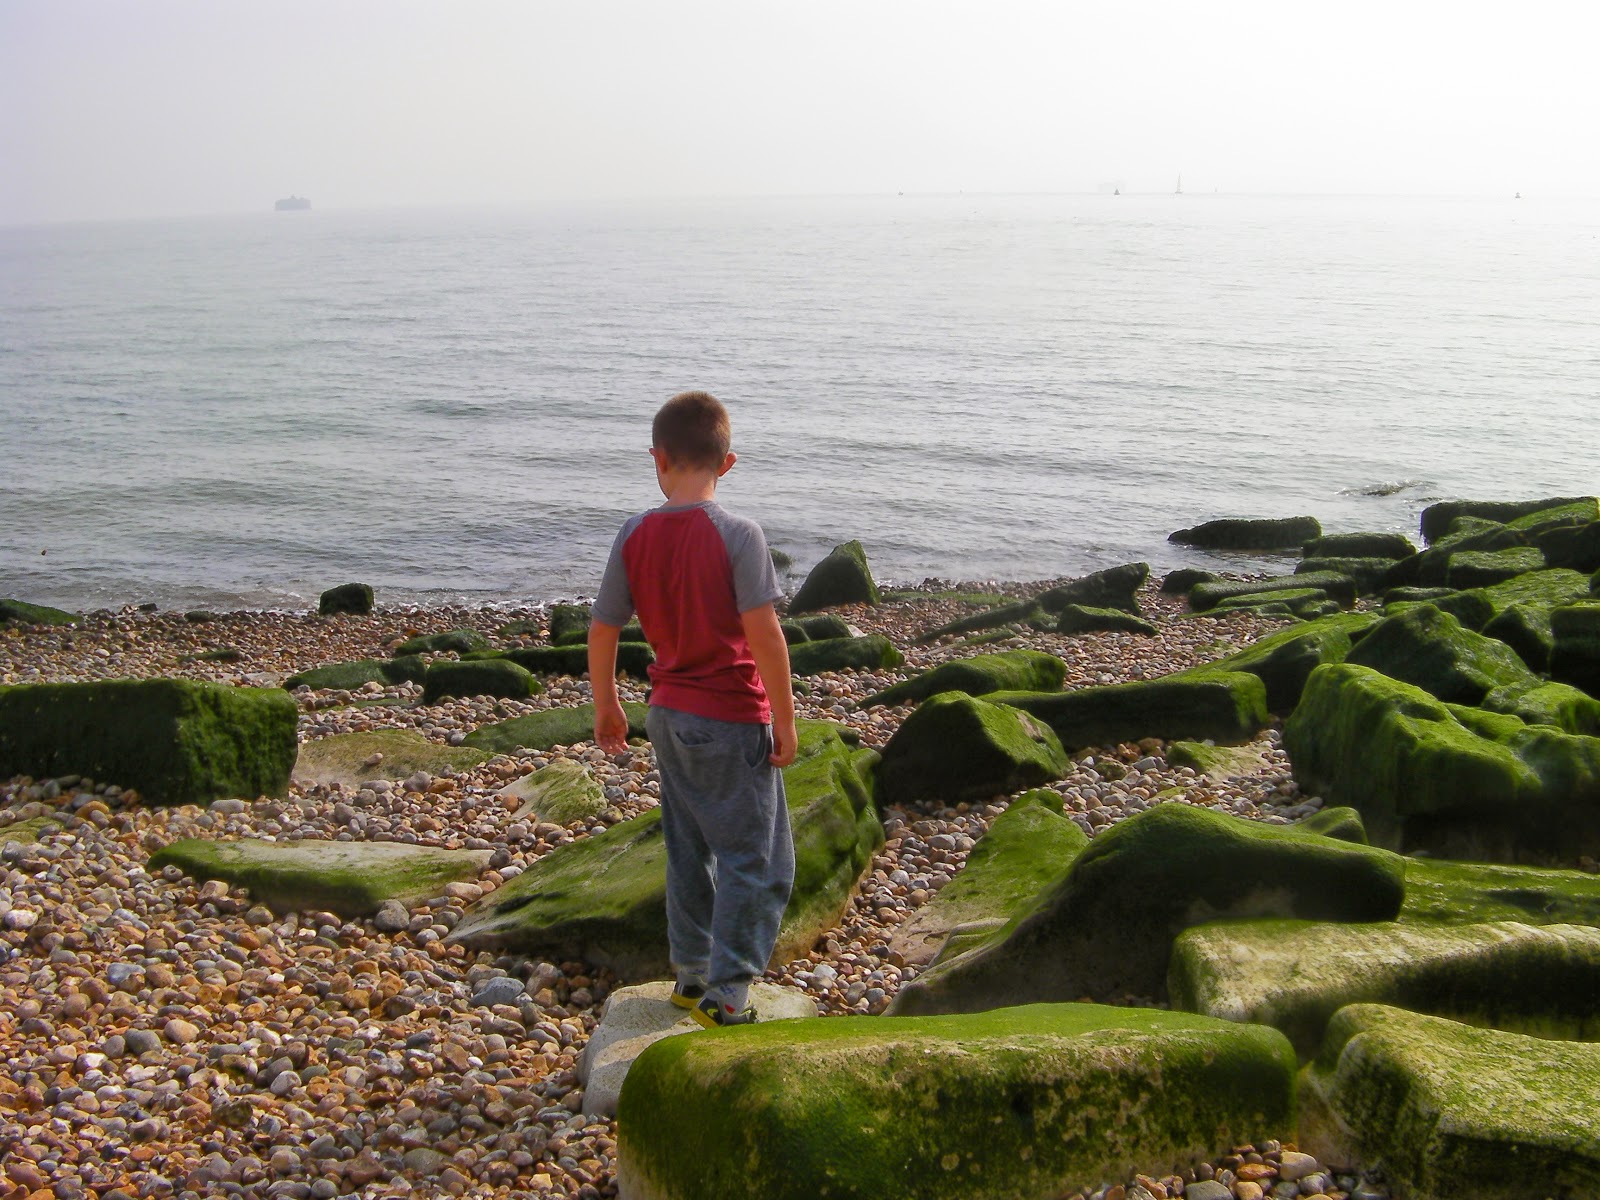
[0,195,1600,608]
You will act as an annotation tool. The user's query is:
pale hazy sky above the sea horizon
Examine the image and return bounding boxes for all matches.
[0,0,1600,224]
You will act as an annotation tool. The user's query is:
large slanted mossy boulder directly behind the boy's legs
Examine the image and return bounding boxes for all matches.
[451,720,883,979]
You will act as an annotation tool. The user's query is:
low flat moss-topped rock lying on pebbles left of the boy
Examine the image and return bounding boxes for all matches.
[150,838,491,917]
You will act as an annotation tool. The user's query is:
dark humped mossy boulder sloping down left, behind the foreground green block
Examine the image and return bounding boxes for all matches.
[891,802,1405,1013]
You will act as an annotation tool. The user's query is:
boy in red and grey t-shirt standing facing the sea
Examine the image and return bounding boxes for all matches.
[589,392,795,1027]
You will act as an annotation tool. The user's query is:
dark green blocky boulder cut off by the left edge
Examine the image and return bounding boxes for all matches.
[0,678,299,805]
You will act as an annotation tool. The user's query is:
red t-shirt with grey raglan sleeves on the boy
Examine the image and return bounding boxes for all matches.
[594,501,784,723]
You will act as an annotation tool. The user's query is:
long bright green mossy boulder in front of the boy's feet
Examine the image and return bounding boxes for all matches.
[618,1005,1294,1200]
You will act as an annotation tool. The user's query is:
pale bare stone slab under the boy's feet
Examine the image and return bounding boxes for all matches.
[578,979,816,1117]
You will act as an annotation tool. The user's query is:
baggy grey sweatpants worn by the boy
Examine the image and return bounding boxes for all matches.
[645,706,795,987]
